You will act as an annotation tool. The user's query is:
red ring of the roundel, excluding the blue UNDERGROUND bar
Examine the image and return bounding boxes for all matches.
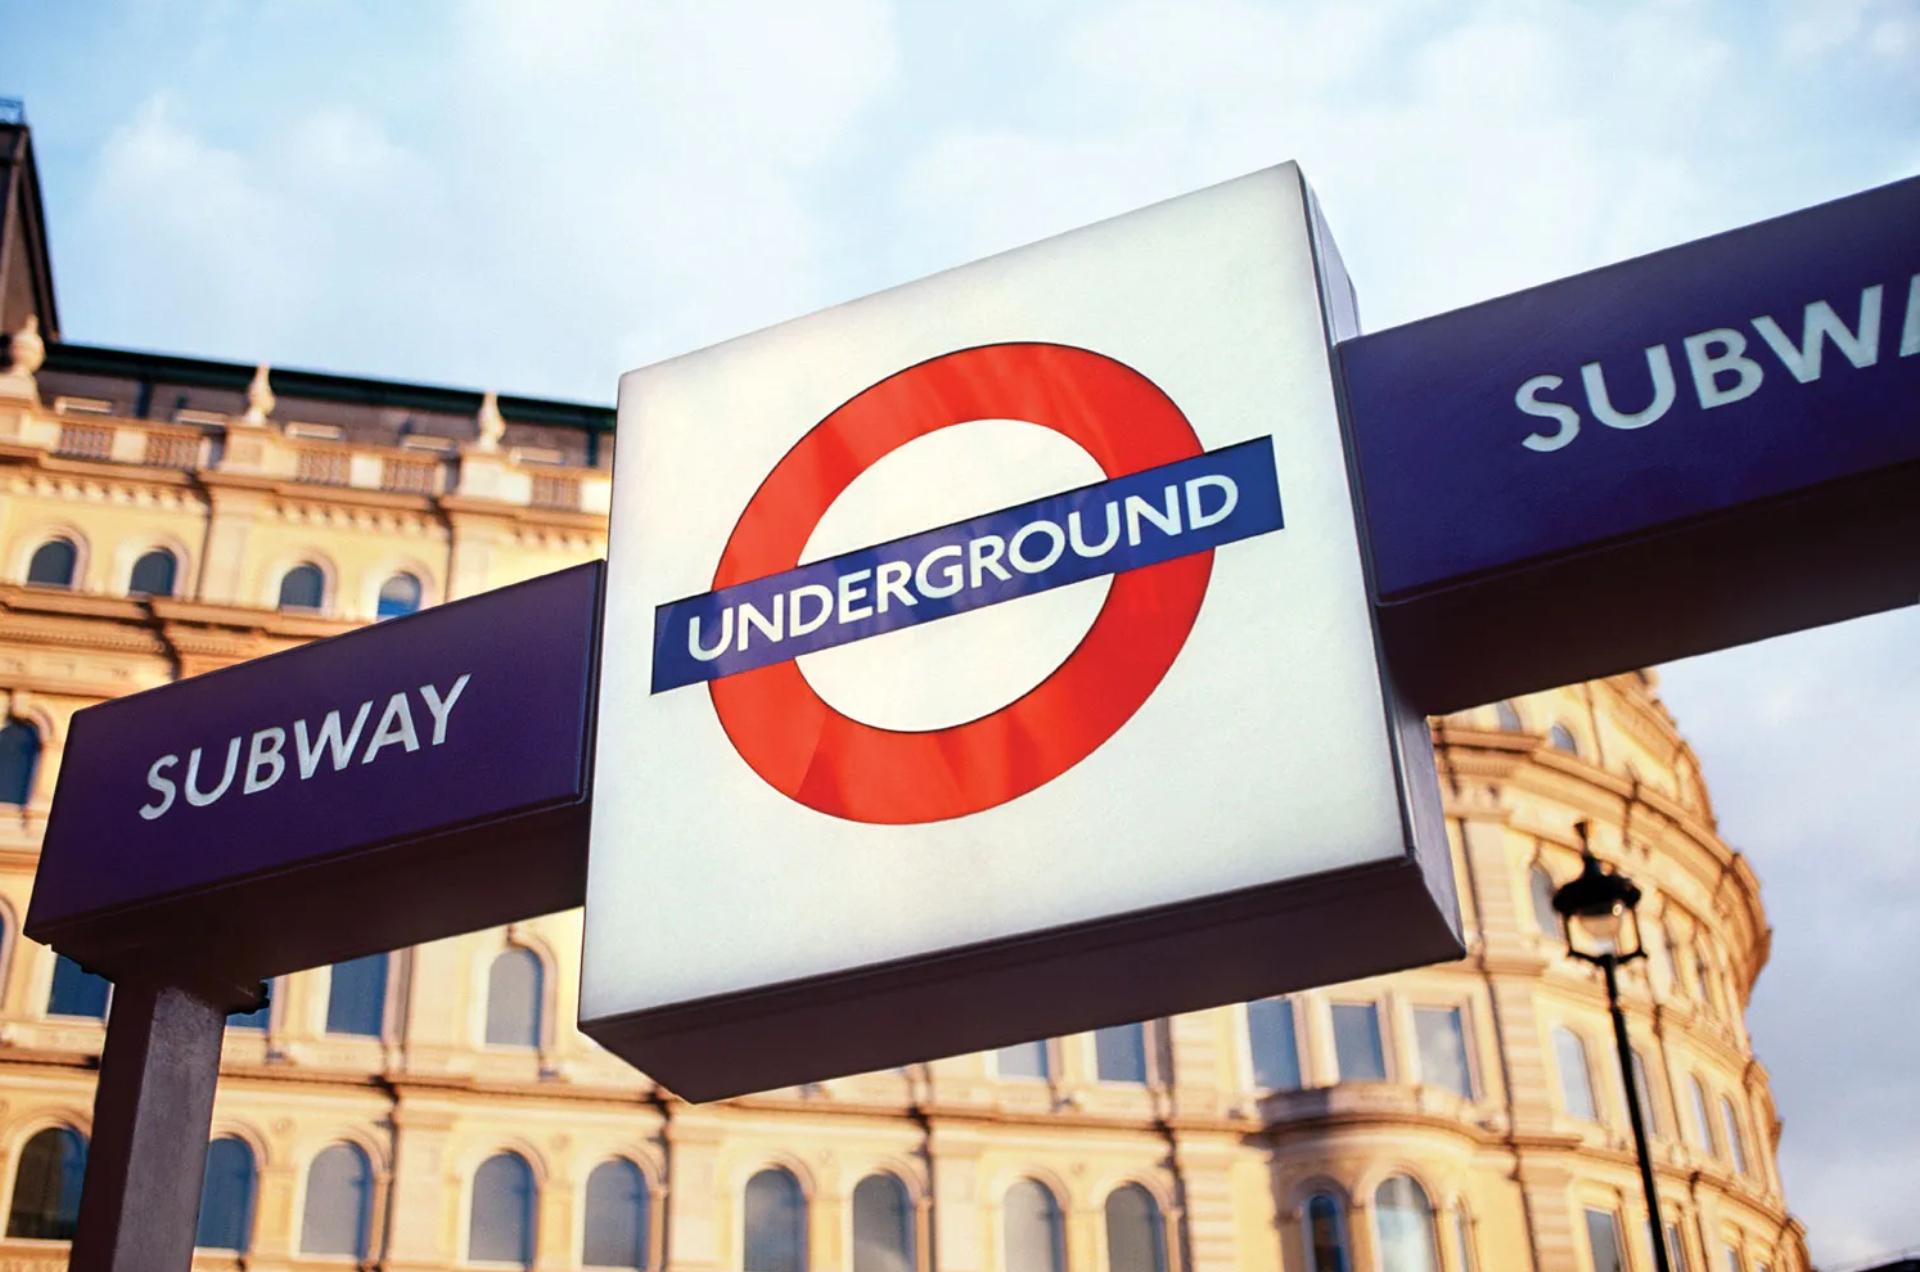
[708,344,1213,826]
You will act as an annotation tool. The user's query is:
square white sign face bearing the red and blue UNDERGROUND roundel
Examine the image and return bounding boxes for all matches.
[582,165,1432,1052]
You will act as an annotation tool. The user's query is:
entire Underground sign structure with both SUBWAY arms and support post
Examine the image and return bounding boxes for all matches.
[25,165,1920,1268]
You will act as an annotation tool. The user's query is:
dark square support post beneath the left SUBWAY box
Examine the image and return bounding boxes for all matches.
[69,976,259,1272]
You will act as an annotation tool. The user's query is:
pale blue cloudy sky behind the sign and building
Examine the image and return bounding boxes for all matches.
[0,0,1920,1266]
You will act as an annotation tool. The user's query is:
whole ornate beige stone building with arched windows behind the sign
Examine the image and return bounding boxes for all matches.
[0,107,1807,1272]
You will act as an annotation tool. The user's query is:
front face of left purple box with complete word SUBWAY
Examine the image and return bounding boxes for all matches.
[27,563,601,942]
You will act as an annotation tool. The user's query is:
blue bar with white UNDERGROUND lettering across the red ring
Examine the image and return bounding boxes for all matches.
[653,438,1281,694]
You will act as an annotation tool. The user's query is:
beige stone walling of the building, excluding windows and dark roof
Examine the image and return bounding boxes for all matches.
[0,388,1807,1272]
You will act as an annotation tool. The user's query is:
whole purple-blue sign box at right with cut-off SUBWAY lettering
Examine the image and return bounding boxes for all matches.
[1340,179,1920,713]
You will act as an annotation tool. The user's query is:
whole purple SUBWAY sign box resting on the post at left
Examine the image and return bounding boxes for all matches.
[25,561,603,980]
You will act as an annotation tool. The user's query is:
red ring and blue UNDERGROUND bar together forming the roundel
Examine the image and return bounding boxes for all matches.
[653,344,1281,822]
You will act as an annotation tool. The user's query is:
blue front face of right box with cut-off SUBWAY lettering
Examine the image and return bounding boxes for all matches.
[1340,179,1920,599]
